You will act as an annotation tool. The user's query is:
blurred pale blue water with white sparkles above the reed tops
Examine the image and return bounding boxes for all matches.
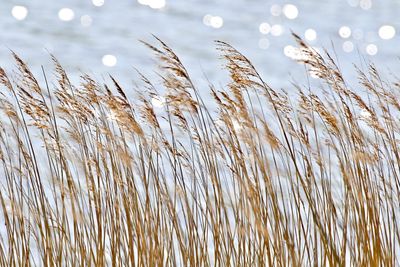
[0,0,400,90]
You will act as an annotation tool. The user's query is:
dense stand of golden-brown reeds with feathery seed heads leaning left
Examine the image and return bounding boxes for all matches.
[0,34,400,266]
